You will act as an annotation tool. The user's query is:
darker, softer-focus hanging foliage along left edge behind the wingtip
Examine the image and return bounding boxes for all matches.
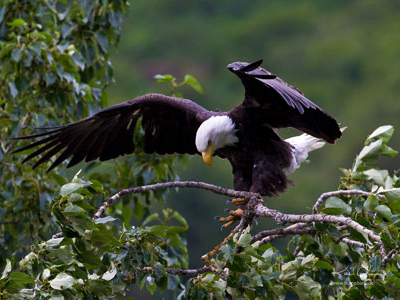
[0,0,127,266]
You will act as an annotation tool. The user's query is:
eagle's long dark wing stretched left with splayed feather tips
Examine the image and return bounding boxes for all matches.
[14,94,211,171]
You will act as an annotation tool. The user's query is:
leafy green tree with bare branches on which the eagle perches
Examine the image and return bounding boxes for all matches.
[0,0,400,299]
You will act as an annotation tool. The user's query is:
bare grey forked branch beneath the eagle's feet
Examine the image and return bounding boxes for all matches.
[93,181,388,277]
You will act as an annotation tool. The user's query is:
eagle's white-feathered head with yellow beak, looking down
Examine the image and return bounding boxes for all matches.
[196,116,239,166]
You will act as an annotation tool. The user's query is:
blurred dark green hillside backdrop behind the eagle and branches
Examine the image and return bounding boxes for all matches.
[104,0,400,267]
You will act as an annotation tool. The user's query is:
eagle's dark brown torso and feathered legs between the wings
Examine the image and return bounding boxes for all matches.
[217,105,292,196]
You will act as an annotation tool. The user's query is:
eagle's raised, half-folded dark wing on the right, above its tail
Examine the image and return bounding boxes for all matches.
[228,61,342,143]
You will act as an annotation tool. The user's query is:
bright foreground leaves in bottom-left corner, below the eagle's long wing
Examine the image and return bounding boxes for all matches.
[0,172,188,299]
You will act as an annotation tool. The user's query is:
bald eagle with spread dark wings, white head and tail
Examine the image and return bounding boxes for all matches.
[14,60,341,196]
